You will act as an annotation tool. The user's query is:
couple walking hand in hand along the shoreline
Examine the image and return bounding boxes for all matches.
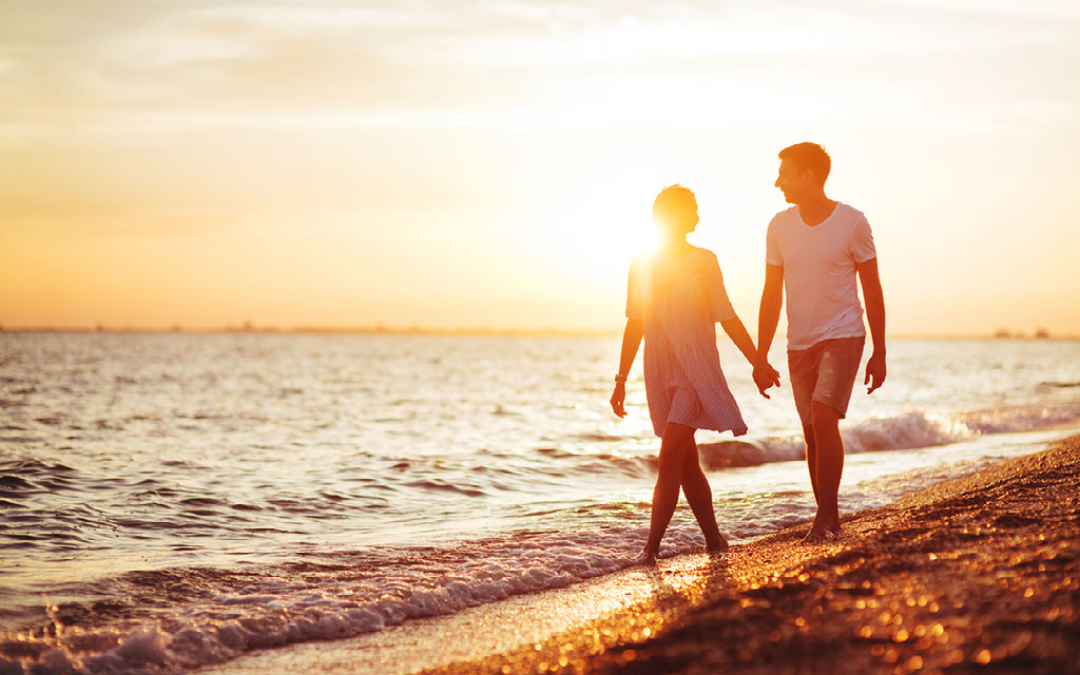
[611,143,886,562]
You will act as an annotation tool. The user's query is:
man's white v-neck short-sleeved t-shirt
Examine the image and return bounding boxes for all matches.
[765,202,877,349]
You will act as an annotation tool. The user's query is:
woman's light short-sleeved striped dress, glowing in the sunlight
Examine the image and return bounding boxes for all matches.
[626,248,746,436]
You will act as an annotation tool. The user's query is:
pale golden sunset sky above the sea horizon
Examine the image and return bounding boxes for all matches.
[0,0,1080,335]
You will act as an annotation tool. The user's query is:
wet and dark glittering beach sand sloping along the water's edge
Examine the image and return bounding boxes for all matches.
[202,436,1080,675]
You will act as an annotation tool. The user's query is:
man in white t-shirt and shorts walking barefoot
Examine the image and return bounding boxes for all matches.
[754,143,886,542]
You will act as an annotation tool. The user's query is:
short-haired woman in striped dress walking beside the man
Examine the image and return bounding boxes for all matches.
[611,185,780,564]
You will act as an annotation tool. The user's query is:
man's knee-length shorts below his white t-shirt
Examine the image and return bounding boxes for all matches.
[787,336,866,427]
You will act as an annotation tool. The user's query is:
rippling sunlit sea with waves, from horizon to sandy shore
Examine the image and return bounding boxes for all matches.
[0,333,1080,674]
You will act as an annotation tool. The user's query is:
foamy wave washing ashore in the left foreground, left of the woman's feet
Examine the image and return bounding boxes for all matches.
[0,527,704,675]
